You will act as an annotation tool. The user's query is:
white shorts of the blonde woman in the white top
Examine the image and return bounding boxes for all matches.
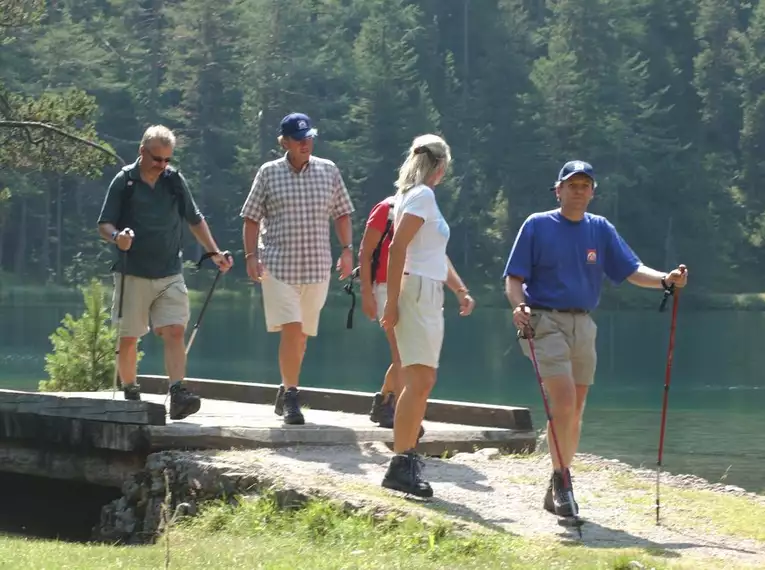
[394,275,444,368]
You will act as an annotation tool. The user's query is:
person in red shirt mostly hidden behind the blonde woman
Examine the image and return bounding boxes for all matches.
[359,196,403,429]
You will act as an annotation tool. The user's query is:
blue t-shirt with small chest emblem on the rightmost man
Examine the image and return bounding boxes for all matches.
[504,210,640,311]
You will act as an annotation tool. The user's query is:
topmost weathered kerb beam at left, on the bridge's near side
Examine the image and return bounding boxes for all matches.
[0,390,167,426]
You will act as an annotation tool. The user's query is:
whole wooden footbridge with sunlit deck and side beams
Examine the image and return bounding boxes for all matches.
[0,377,536,487]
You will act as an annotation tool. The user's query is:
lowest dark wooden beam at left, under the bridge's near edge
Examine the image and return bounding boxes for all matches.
[0,440,146,489]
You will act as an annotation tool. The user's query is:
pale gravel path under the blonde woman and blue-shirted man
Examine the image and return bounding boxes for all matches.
[243,444,765,568]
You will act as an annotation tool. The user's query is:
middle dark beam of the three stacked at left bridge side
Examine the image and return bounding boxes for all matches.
[0,410,151,452]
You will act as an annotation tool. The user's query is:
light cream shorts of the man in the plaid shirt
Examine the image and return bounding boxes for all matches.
[260,270,329,336]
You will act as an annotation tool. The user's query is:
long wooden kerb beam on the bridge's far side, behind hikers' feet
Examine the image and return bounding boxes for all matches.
[138,374,533,430]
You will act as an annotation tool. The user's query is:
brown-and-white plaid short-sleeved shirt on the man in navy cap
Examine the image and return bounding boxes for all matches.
[240,154,354,285]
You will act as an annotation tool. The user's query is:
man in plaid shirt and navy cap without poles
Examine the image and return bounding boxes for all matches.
[240,113,353,425]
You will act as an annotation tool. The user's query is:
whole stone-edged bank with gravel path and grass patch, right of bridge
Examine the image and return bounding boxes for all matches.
[95,444,765,568]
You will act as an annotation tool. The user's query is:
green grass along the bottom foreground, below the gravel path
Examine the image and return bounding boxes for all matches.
[0,492,760,570]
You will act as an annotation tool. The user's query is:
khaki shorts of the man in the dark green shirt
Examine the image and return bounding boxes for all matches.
[112,273,190,338]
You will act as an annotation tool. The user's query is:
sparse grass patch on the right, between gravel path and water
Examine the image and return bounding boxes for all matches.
[614,474,765,542]
